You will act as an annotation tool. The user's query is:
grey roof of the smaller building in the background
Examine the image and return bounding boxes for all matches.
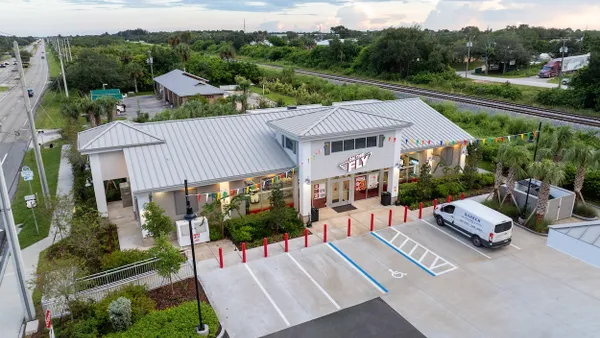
[154,69,225,97]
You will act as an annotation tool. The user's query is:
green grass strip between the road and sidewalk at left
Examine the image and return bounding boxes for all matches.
[12,142,62,249]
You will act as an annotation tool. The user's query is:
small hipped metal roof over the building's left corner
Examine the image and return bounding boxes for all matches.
[78,121,165,154]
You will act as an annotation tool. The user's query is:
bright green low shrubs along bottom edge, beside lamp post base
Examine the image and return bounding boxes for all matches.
[106,301,219,338]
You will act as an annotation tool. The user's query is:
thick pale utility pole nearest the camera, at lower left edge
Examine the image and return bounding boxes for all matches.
[0,156,35,322]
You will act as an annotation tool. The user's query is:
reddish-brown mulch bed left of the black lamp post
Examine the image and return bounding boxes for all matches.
[148,277,210,310]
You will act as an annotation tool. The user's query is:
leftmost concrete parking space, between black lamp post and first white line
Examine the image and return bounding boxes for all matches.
[199,264,287,337]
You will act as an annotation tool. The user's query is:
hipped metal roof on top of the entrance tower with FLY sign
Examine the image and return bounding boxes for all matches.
[267,106,411,140]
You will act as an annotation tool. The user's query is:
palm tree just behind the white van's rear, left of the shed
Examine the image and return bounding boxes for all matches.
[498,143,530,207]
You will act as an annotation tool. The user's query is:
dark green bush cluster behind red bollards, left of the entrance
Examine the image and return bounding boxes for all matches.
[225,207,304,247]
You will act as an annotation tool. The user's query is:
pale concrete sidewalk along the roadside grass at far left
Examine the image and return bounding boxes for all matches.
[0,145,73,338]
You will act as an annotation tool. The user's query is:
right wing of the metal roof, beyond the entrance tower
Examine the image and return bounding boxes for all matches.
[347,98,474,151]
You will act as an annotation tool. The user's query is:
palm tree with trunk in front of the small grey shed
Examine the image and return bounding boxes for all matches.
[528,159,565,223]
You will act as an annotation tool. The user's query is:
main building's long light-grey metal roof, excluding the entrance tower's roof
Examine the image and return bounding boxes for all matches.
[78,99,471,192]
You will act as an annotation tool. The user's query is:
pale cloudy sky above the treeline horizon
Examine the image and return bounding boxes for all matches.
[0,0,600,36]
